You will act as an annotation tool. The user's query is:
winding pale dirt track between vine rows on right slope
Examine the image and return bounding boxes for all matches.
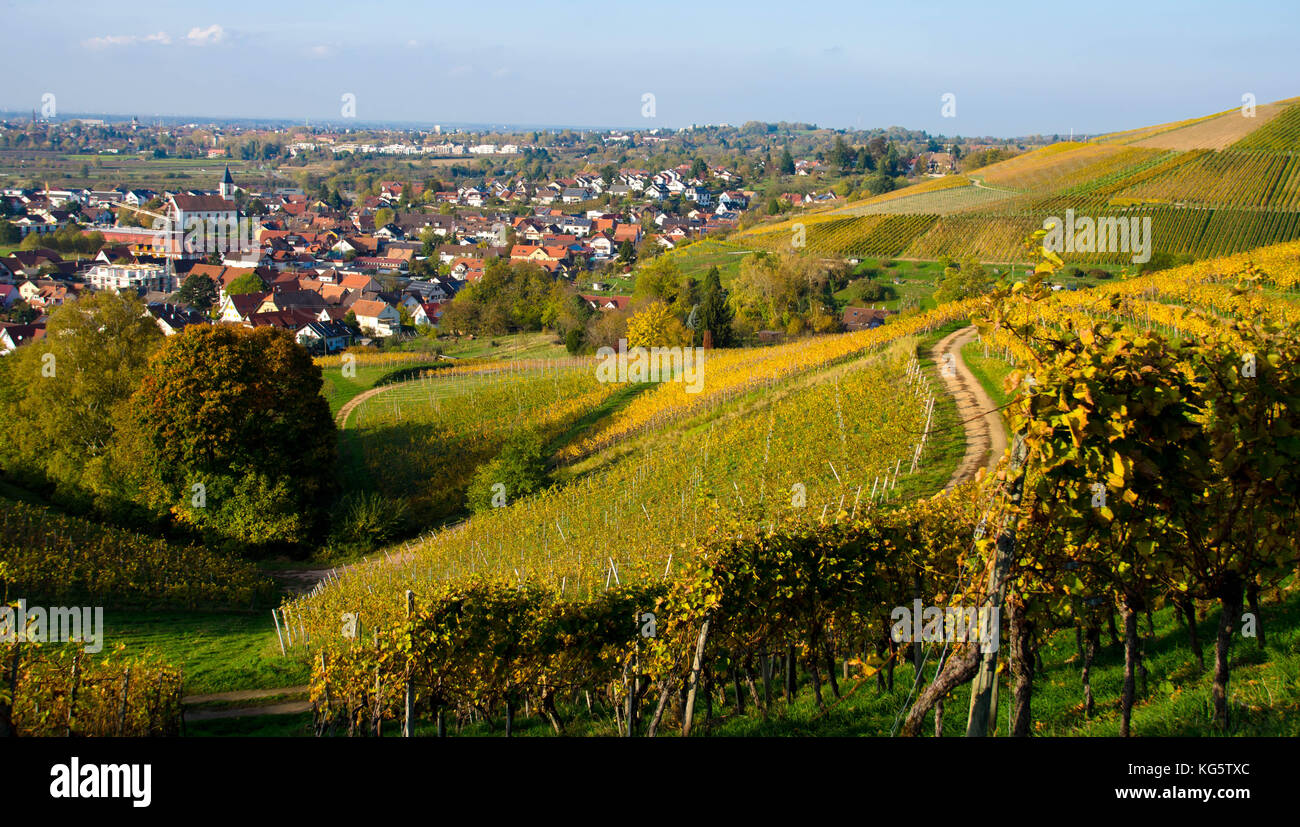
[930,326,1006,490]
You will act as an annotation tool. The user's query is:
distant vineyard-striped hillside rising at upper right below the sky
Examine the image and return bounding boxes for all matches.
[737,98,1300,264]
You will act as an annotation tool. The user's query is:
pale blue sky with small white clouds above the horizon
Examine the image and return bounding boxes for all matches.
[0,0,1300,137]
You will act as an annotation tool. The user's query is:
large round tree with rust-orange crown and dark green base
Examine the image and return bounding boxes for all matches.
[122,325,337,547]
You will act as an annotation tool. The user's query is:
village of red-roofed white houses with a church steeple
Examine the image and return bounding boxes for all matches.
[0,154,754,354]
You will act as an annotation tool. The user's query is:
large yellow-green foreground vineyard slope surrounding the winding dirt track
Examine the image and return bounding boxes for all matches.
[261,235,1300,735]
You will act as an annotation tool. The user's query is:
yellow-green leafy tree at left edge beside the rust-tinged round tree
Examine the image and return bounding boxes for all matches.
[0,293,163,507]
